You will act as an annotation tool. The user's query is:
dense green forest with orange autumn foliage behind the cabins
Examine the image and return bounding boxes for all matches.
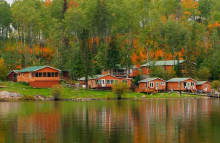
[0,0,220,80]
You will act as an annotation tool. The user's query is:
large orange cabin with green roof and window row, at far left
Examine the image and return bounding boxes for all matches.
[17,66,60,88]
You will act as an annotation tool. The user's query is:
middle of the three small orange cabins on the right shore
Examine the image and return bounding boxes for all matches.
[167,78,197,92]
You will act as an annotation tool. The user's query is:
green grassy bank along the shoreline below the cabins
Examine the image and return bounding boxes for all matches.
[0,82,200,99]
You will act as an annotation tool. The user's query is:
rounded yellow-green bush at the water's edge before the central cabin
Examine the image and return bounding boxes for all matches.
[112,82,129,100]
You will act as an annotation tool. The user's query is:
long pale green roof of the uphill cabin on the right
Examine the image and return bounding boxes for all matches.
[141,60,185,67]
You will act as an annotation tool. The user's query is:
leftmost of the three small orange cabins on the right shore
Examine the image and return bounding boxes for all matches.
[139,78,166,93]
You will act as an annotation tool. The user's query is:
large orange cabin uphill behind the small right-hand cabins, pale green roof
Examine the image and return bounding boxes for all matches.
[141,60,195,76]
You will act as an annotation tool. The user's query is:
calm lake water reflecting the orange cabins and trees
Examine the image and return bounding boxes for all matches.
[0,99,220,143]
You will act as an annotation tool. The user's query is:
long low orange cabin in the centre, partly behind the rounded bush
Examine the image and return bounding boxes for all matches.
[79,74,131,88]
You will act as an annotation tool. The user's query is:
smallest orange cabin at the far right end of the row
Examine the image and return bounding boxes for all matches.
[196,81,211,93]
